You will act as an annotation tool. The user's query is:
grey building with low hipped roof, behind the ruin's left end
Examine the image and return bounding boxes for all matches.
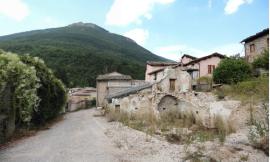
[96,72,145,107]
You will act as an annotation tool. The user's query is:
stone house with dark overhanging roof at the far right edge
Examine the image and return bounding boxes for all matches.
[241,28,269,62]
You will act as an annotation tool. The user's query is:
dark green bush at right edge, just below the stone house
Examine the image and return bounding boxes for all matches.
[252,50,269,70]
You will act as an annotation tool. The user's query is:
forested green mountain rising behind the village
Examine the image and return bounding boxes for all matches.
[0,22,169,87]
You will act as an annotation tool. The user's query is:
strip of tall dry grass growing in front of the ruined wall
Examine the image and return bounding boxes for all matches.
[106,110,231,144]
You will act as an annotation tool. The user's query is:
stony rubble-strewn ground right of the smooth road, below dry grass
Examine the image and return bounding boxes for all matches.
[105,122,268,162]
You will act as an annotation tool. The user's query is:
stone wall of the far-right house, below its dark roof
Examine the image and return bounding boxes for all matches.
[244,35,269,62]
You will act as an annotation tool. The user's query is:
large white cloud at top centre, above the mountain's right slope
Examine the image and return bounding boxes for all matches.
[106,0,175,26]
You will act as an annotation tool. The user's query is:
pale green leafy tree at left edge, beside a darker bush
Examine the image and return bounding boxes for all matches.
[0,50,39,124]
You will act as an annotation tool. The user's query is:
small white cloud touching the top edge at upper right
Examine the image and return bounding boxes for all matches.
[224,0,253,15]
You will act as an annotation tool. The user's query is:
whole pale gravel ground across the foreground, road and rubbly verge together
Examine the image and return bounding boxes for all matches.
[0,109,268,162]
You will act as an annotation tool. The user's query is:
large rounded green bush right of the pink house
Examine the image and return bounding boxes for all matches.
[213,58,251,84]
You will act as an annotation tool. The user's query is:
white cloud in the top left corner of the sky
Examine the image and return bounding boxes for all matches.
[0,0,30,21]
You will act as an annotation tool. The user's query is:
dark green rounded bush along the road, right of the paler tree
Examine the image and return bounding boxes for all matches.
[21,55,67,124]
